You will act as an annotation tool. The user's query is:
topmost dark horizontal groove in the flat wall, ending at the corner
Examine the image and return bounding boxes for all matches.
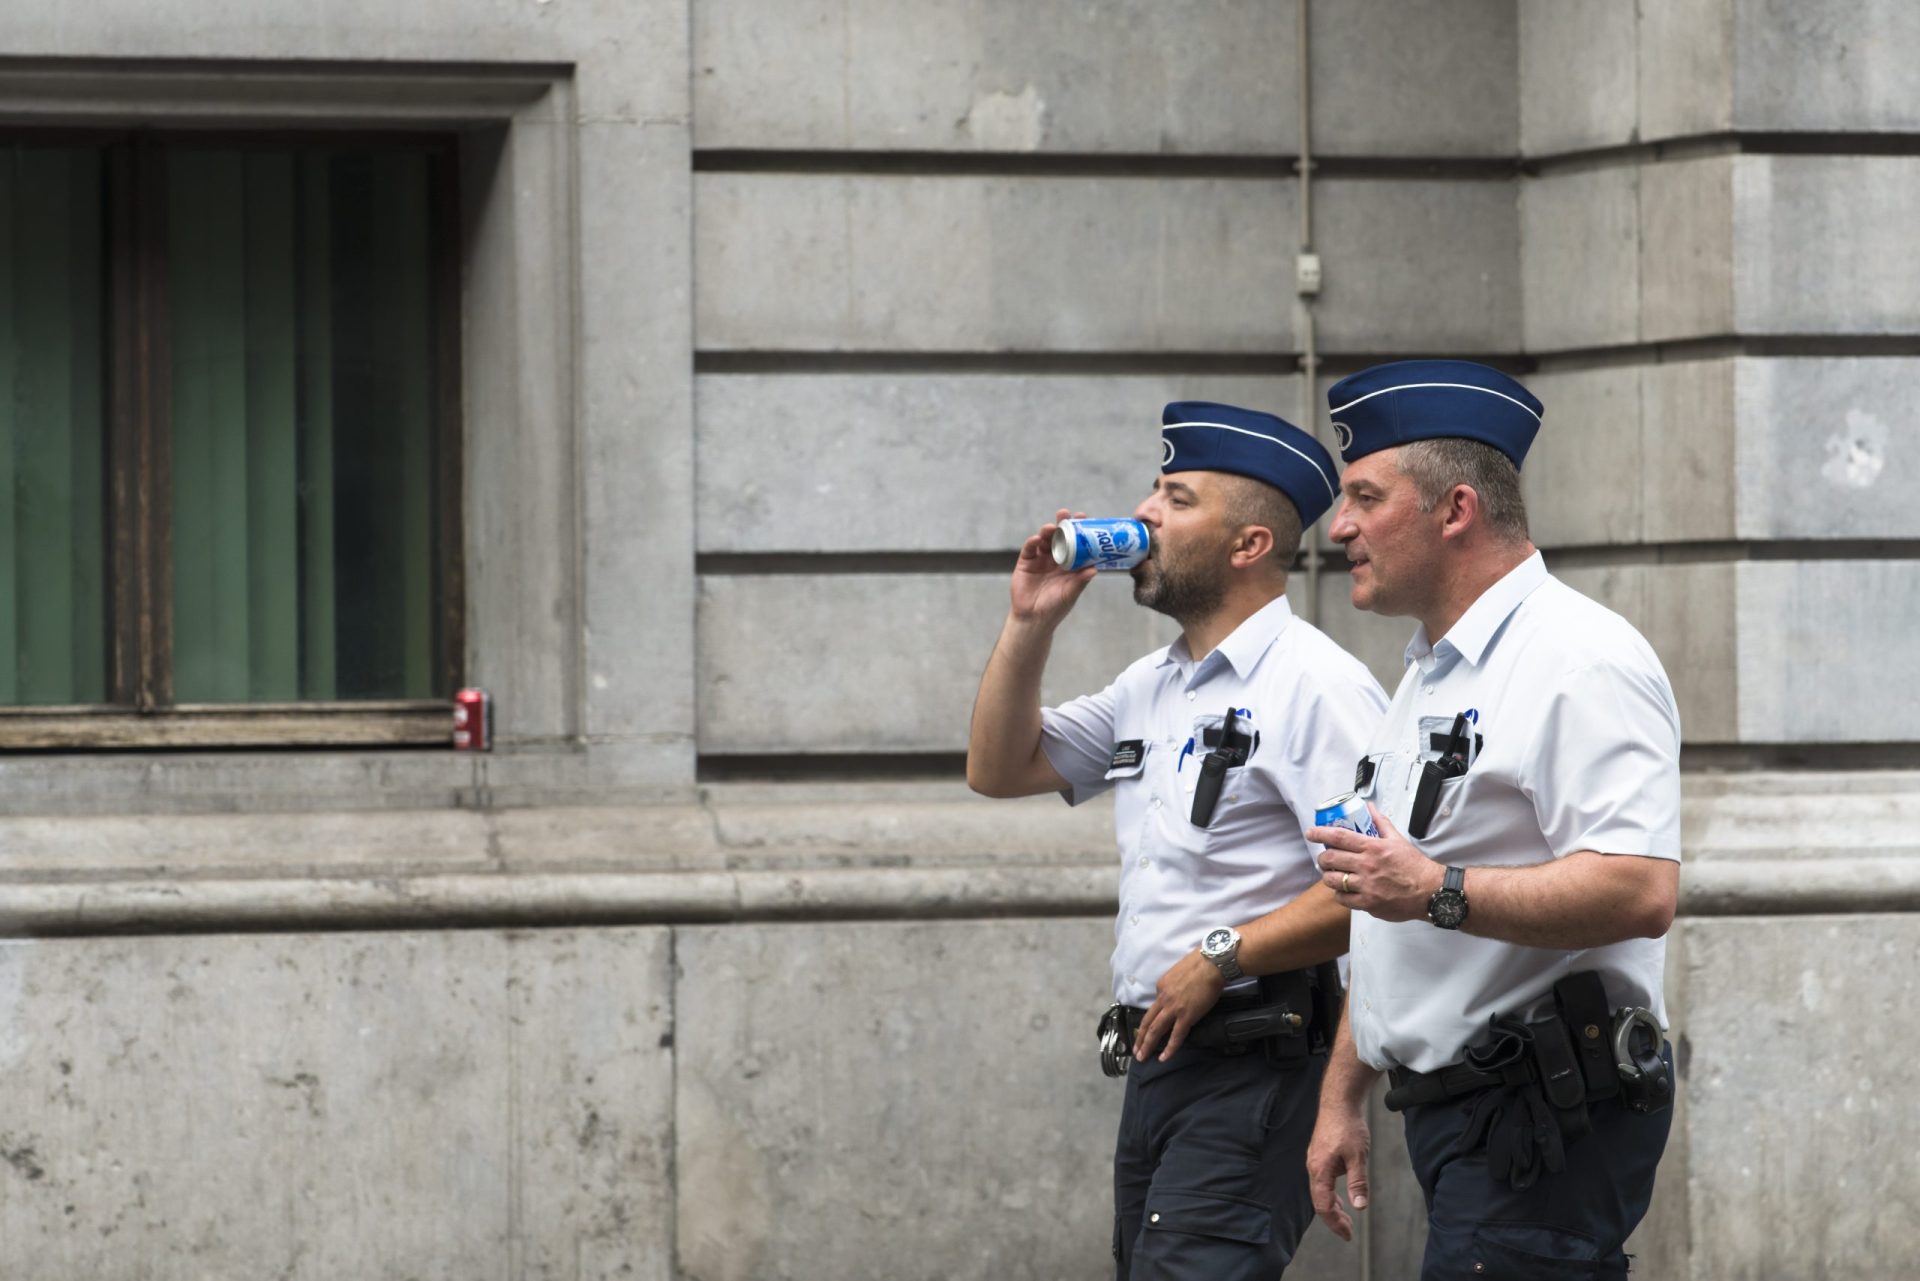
[693,148,1519,182]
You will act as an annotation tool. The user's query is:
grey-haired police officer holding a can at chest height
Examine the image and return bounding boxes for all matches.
[1308,361,1680,1281]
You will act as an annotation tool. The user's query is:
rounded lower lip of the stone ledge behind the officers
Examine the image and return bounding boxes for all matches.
[0,857,1920,937]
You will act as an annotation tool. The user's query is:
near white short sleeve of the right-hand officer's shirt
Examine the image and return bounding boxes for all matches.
[1523,655,1680,862]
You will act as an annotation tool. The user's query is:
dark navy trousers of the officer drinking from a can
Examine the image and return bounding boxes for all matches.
[1114,1049,1327,1281]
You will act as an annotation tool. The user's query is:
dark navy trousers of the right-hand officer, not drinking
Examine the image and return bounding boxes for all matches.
[1405,1051,1672,1281]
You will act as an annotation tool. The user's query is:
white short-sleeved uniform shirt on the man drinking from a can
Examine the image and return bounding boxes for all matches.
[1041,595,1386,1006]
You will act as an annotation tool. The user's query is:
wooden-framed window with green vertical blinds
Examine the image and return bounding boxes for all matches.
[0,131,465,749]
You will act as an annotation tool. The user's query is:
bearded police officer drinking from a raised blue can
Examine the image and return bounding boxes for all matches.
[968,401,1386,1281]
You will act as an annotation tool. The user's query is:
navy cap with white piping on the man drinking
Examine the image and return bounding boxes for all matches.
[1160,399,1340,530]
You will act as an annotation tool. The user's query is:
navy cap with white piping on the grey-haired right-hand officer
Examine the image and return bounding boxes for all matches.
[1327,361,1542,469]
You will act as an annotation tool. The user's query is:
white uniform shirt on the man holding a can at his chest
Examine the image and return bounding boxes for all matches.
[1348,551,1680,1072]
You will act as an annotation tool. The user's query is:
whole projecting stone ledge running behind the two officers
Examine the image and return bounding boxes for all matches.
[0,770,1920,937]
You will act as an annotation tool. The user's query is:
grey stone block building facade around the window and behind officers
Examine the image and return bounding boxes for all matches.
[0,0,1920,1281]
